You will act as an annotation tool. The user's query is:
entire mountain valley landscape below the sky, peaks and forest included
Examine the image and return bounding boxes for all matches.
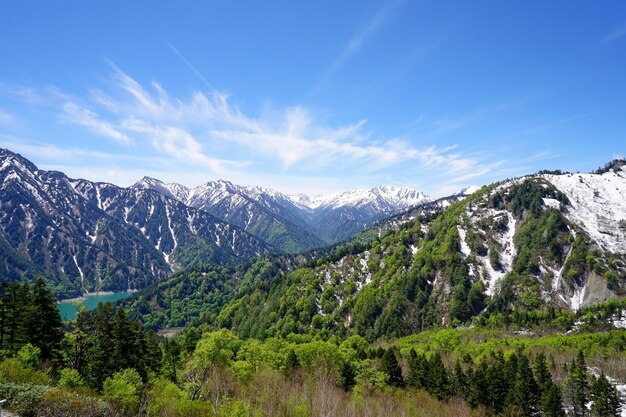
[0,151,626,416]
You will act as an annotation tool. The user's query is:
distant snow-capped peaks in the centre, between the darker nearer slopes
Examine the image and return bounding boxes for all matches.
[133,177,430,244]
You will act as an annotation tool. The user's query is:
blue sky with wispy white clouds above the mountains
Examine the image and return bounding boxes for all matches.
[0,0,626,196]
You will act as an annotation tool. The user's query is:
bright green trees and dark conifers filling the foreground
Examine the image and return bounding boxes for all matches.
[0,281,626,417]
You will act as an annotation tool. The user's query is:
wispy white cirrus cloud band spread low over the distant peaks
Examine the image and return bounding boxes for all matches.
[2,64,502,195]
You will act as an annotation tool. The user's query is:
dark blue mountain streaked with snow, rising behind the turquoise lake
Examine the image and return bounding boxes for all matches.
[0,149,272,295]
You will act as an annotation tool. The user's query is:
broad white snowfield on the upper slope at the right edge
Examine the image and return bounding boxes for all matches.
[544,168,626,253]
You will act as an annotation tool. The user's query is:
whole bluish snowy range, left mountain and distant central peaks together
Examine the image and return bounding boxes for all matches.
[0,149,428,297]
